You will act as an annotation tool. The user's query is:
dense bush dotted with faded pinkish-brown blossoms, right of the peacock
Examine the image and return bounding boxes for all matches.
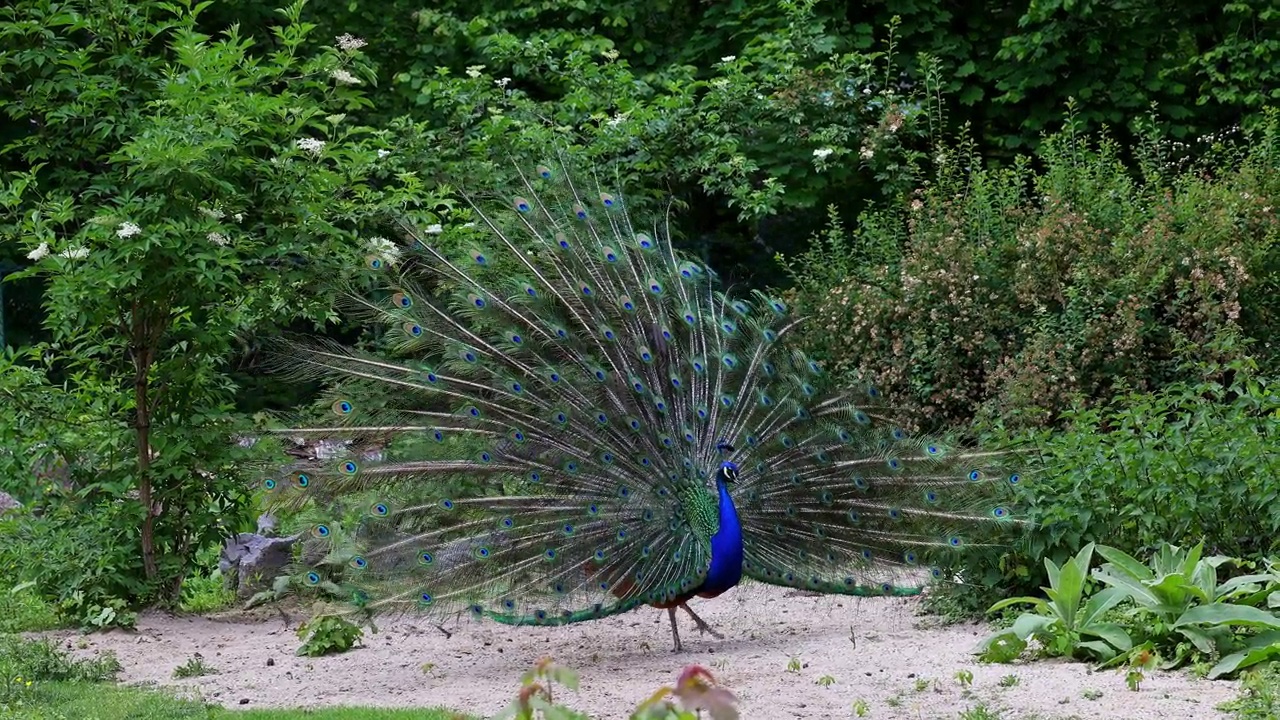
[791,109,1280,427]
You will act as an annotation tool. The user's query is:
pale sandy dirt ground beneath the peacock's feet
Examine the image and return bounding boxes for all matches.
[47,587,1238,720]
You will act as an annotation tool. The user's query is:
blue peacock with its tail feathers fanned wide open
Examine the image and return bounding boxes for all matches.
[264,160,1020,652]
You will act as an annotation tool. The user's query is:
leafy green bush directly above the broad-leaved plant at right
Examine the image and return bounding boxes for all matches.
[942,342,1280,602]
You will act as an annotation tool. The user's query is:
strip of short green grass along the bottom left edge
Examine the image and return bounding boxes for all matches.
[0,683,468,720]
